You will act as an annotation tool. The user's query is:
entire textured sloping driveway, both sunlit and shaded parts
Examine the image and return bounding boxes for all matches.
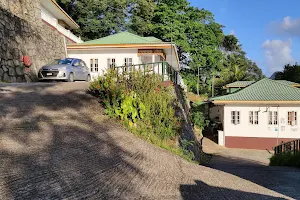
[0,82,300,200]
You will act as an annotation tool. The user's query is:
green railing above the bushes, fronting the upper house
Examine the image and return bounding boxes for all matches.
[113,62,178,84]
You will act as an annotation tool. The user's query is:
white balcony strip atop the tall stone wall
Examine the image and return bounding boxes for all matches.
[41,10,83,43]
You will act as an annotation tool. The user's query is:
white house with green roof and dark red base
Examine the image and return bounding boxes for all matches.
[211,78,300,149]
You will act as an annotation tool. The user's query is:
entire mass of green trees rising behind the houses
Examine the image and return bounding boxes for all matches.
[57,0,263,93]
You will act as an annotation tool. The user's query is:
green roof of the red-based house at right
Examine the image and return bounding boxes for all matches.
[210,78,300,101]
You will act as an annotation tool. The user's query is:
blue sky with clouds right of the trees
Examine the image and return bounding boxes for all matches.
[189,0,300,77]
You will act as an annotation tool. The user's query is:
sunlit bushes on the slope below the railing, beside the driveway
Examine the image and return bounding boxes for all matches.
[89,71,194,160]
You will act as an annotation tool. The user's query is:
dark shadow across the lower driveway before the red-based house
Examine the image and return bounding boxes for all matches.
[208,155,300,199]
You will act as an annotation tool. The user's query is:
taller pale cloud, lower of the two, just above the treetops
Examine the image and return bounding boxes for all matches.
[262,39,294,74]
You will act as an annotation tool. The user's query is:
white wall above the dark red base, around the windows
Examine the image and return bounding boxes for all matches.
[224,105,300,138]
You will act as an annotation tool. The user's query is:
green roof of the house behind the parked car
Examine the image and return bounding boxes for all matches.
[79,32,168,45]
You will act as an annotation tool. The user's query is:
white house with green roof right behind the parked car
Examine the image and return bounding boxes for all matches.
[67,32,180,78]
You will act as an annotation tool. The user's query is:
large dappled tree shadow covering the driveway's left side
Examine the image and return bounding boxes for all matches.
[0,84,143,199]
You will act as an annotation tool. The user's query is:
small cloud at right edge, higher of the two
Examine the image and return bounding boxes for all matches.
[270,16,300,36]
